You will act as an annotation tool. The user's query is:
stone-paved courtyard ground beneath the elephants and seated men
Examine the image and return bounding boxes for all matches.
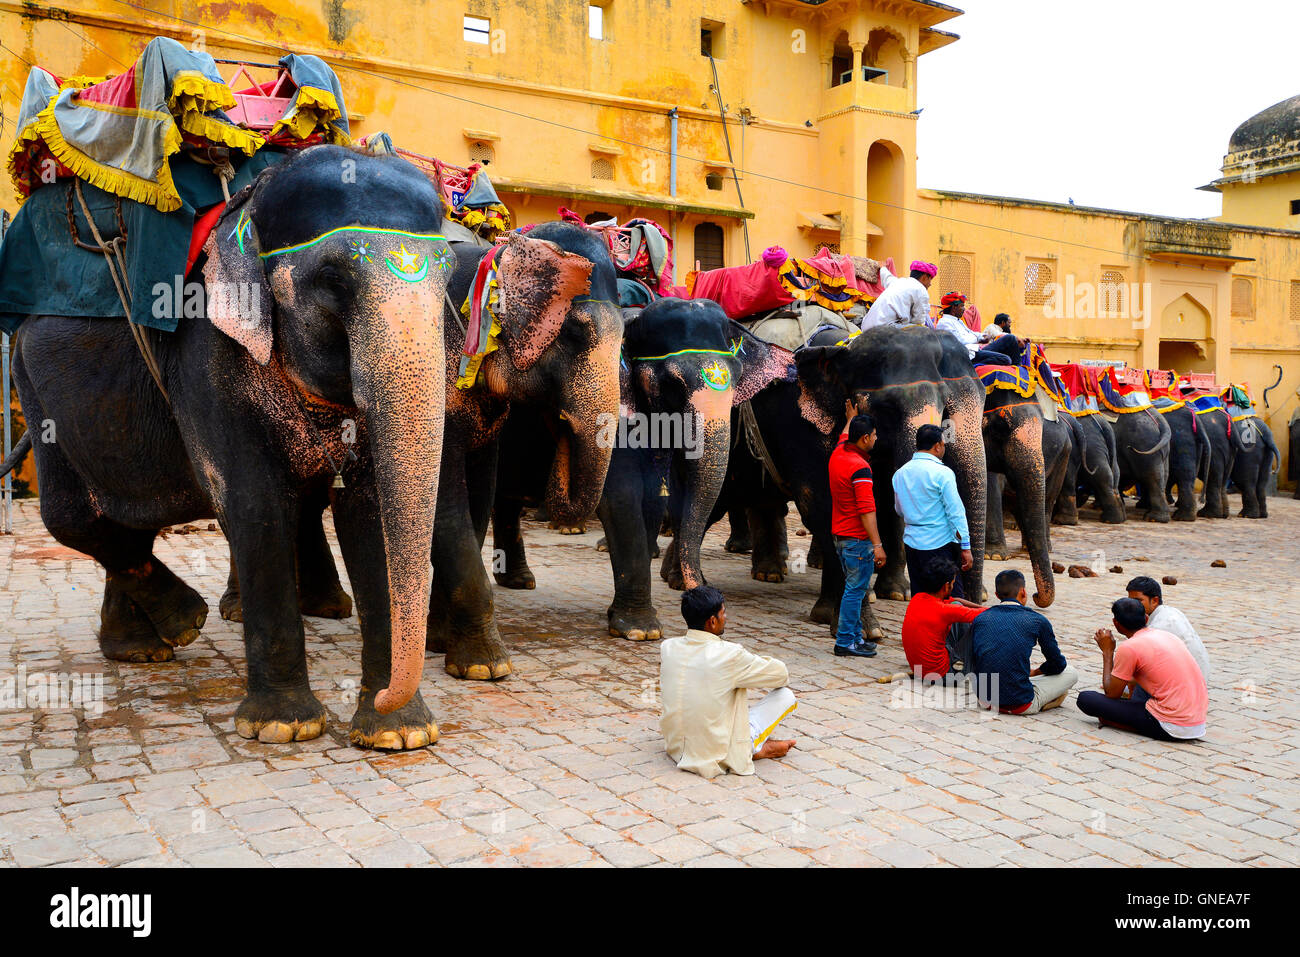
[0,498,1300,866]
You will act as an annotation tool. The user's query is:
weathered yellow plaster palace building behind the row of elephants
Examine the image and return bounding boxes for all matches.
[0,0,1300,481]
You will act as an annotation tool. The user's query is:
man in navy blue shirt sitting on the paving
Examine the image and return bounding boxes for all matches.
[971,568,1079,714]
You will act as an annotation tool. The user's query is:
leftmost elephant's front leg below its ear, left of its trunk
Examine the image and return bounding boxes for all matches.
[222,496,327,744]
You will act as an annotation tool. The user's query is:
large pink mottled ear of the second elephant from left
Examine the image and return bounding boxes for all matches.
[497,233,593,369]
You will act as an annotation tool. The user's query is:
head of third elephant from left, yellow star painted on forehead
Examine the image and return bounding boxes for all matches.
[623,299,793,588]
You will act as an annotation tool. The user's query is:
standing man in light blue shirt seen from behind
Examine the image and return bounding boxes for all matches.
[893,425,975,598]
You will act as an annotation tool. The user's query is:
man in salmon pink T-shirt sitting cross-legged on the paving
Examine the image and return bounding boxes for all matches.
[1078,598,1209,741]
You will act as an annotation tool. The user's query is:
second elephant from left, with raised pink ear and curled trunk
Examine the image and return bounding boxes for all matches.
[428,222,623,680]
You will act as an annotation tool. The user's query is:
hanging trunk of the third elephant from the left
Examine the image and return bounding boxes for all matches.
[677,387,732,589]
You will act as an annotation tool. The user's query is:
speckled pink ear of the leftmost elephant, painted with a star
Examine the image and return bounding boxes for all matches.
[203,185,272,365]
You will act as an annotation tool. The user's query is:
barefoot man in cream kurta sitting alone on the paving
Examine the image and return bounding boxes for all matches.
[659,585,797,778]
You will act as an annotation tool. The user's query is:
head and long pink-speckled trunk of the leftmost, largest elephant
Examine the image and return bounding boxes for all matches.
[204,146,455,713]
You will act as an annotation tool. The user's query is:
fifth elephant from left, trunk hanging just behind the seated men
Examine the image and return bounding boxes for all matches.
[982,389,1074,609]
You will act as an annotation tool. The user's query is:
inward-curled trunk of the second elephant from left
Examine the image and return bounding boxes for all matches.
[546,306,621,525]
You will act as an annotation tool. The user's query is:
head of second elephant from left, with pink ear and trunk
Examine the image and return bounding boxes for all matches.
[470,222,623,525]
